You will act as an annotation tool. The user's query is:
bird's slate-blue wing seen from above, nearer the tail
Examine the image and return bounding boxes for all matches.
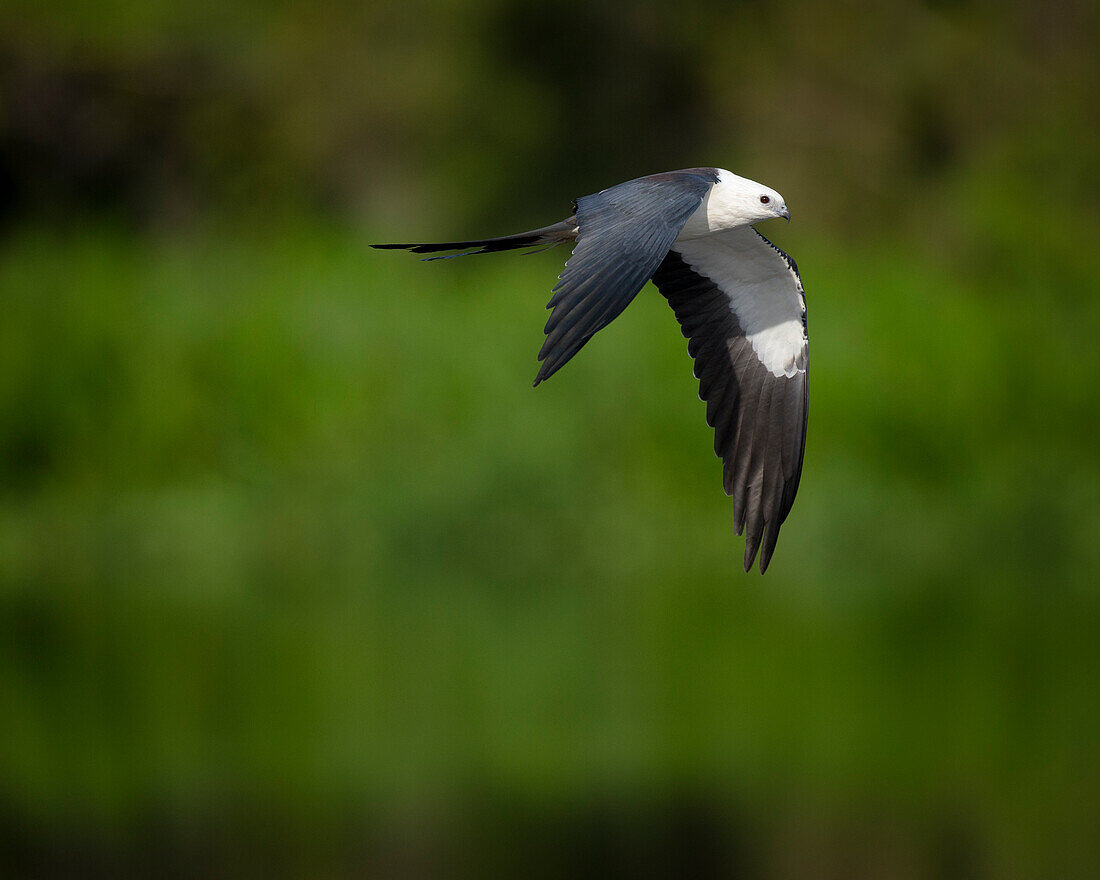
[535,168,718,385]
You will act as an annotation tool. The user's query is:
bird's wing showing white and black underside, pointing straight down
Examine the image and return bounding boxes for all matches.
[653,227,809,573]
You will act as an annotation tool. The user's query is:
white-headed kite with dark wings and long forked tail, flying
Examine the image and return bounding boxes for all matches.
[372,168,809,573]
